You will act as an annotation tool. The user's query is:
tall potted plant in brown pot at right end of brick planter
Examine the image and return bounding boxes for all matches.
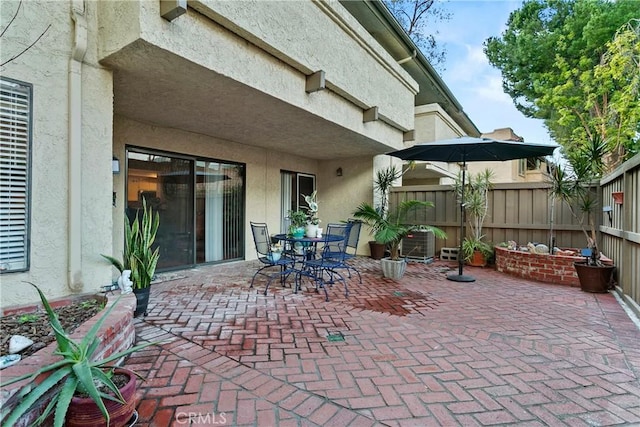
[549,134,615,293]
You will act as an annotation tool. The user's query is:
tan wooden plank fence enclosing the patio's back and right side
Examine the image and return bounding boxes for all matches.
[390,155,640,308]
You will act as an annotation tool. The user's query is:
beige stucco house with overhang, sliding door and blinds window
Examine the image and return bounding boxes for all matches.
[0,0,478,307]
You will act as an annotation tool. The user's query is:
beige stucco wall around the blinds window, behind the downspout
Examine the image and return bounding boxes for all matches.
[0,1,112,307]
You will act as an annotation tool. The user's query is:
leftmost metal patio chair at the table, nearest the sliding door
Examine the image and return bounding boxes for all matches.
[249,222,297,295]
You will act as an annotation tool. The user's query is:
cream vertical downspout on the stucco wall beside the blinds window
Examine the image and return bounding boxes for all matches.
[67,0,87,292]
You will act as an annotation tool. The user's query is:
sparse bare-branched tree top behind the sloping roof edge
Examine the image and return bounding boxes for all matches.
[383,0,451,71]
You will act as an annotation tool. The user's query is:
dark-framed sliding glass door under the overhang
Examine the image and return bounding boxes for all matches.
[127,148,245,271]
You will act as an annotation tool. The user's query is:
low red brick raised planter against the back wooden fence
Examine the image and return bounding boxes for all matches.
[495,246,584,287]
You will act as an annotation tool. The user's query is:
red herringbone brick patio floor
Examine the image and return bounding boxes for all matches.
[126,258,640,427]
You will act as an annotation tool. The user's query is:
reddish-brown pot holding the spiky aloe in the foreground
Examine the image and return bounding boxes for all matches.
[65,368,136,427]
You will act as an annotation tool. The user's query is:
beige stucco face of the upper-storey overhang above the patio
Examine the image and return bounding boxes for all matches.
[95,0,418,148]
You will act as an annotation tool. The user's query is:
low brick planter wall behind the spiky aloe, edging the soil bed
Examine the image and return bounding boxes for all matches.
[0,294,136,427]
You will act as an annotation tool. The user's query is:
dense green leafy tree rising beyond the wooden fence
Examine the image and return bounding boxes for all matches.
[485,0,640,162]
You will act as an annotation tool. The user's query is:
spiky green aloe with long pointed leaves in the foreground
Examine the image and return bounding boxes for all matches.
[0,283,157,427]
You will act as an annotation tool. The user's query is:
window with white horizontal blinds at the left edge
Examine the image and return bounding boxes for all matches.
[0,77,32,273]
